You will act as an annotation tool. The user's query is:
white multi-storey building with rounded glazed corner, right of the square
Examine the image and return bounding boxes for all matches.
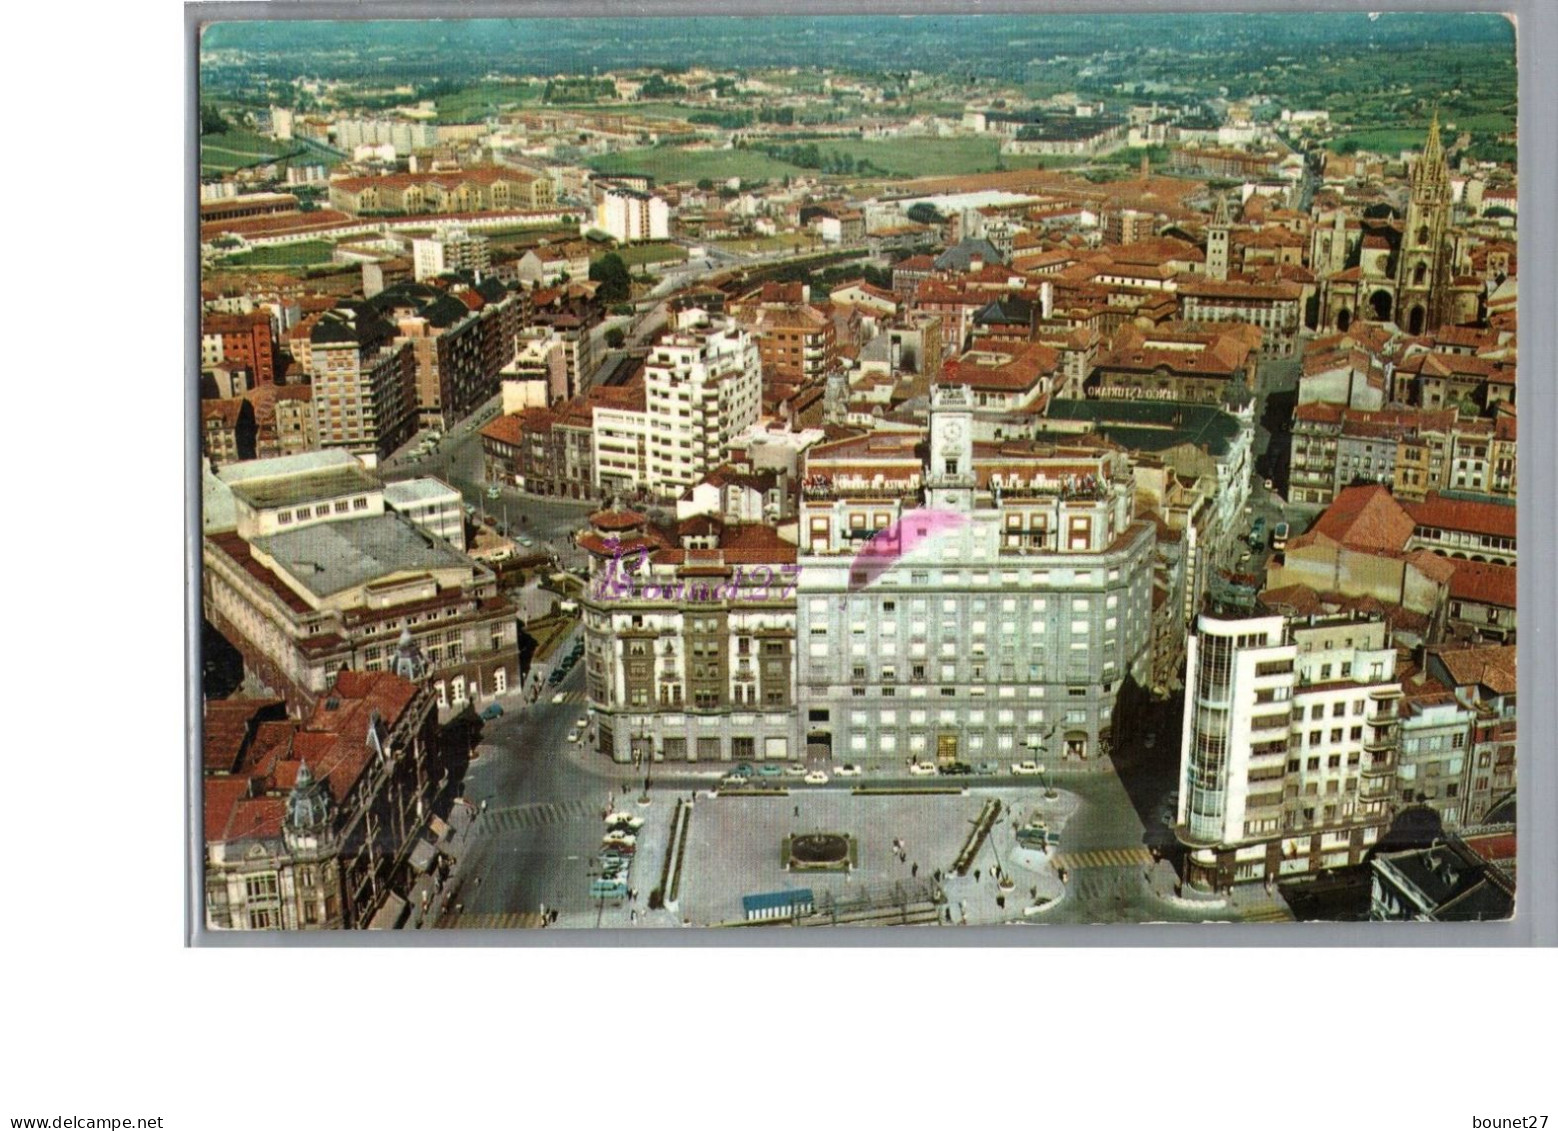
[1175,612,1401,888]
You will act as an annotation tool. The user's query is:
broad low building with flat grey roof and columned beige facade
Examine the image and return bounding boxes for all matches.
[201,452,519,710]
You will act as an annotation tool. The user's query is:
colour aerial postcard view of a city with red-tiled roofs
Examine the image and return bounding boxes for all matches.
[189,12,1519,938]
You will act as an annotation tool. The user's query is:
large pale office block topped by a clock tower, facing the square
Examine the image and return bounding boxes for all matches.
[796,385,1156,768]
